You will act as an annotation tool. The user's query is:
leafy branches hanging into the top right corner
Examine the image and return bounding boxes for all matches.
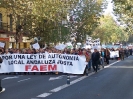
[113,0,133,35]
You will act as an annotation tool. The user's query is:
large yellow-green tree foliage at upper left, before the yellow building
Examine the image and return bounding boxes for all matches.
[0,0,78,42]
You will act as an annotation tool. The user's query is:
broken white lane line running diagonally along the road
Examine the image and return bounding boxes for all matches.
[37,61,120,97]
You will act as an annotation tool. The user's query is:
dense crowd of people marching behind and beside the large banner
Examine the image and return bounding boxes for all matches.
[0,47,132,75]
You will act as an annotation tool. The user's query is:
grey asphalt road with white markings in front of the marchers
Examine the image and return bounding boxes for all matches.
[0,56,133,99]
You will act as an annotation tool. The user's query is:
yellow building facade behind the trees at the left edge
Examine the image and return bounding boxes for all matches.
[0,8,31,49]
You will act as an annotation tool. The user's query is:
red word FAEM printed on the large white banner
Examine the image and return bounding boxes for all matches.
[25,65,57,72]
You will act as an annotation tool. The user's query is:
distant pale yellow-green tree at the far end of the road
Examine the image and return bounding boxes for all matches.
[92,15,128,43]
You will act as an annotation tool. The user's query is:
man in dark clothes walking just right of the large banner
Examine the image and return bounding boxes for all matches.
[92,49,100,72]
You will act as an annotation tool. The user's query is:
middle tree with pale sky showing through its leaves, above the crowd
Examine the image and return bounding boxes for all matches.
[66,0,107,42]
